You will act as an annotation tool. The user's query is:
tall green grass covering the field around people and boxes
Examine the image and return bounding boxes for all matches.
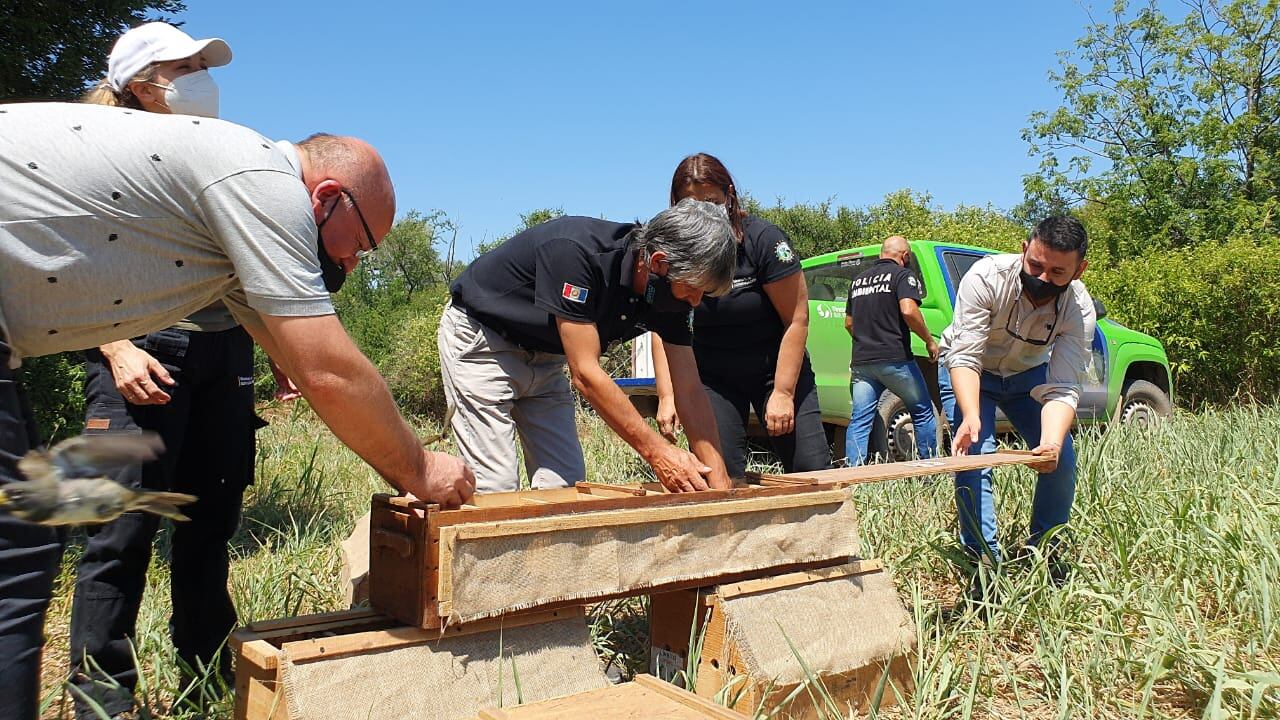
[35,406,1280,719]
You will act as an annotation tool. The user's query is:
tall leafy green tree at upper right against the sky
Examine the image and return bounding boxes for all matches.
[1023,0,1280,256]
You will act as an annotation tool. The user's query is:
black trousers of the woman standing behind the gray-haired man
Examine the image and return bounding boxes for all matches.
[694,346,831,478]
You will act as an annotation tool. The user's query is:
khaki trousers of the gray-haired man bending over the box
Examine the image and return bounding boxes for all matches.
[436,304,586,492]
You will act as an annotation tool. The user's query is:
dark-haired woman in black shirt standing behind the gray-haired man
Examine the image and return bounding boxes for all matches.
[654,152,831,478]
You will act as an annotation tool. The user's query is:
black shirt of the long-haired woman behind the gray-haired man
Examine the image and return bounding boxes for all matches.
[694,215,800,352]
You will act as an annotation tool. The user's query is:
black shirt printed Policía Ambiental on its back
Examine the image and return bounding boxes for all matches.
[845,260,920,365]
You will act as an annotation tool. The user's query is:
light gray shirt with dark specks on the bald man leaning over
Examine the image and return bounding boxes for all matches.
[0,102,333,361]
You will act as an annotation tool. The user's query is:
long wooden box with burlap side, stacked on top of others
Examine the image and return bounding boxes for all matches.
[369,482,859,628]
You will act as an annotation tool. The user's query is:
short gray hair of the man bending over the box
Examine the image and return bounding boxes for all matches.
[631,197,737,296]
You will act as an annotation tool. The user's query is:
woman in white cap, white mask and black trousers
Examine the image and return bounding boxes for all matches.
[70,23,260,717]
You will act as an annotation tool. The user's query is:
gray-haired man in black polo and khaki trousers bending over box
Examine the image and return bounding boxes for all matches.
[438,200,736,492]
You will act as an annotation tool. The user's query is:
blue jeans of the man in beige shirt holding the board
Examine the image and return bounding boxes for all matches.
[938,363,1075,561]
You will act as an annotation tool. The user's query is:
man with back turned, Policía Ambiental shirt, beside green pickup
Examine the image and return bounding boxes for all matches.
[845,234,938,465]
